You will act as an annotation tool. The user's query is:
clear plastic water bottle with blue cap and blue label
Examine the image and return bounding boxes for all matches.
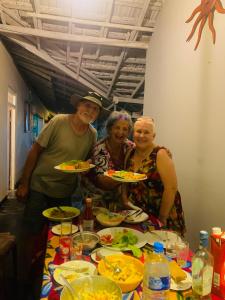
[142,242,170,300]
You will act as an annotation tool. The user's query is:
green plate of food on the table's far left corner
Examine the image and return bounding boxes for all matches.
[42,206,80,221]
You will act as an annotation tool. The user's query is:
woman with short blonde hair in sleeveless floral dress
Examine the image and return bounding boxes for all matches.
[123,117,185,235]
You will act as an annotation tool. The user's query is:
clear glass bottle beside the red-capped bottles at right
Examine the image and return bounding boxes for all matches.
[192,230,213,299]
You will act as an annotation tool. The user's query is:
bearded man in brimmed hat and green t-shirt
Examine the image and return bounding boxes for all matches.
[17,93,104,298]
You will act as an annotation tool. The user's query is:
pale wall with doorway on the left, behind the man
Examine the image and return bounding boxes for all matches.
[0,40,47,201]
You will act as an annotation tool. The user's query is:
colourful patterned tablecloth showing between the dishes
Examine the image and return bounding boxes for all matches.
[40,216,222,300]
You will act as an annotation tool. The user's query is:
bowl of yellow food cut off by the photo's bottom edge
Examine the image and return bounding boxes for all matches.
[60,275,122,300]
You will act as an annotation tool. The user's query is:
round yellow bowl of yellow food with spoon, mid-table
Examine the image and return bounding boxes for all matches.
[98,254,144,293]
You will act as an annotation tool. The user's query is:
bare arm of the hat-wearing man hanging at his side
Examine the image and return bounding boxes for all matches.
[16,143,44,200]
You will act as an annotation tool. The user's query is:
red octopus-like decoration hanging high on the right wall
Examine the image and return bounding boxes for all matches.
[186,0,225,50]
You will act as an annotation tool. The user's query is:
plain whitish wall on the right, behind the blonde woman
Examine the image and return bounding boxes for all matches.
[144,0,225,247]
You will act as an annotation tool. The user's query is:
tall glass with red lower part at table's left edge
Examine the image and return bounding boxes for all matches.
[59,221,72,261]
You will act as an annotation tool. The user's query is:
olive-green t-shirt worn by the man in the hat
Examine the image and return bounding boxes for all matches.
[31,115,96,198]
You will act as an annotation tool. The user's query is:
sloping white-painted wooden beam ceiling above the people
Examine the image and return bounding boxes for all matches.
[0,0,163,112]
